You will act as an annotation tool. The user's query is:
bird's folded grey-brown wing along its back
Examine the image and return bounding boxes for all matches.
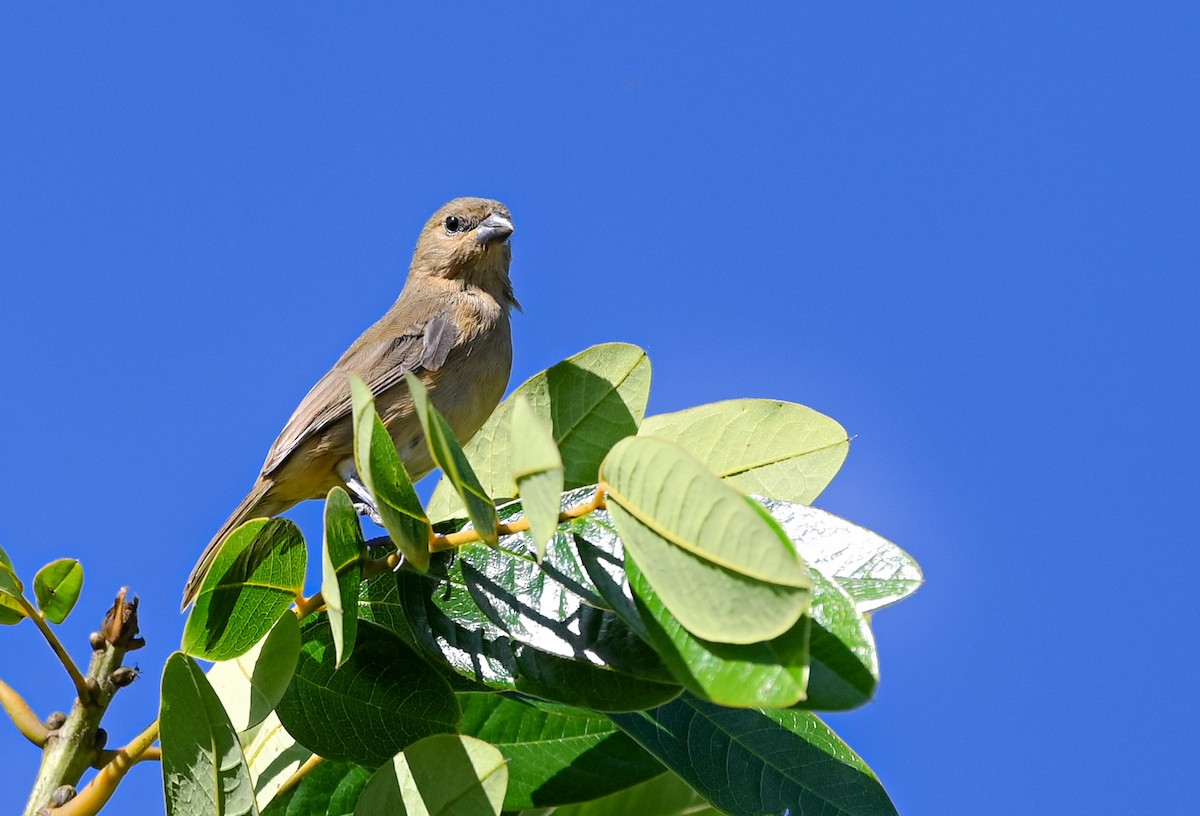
[263,310,458,475]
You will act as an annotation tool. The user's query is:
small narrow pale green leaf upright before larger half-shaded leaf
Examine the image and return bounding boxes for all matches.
[511,395,563,560]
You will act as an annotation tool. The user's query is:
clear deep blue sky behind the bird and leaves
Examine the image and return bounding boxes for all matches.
[0,0,1200,815]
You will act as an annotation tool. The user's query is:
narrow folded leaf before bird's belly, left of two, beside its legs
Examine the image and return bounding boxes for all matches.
[348,373,432,572]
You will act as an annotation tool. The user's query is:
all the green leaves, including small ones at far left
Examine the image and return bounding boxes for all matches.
[0,343,922,816]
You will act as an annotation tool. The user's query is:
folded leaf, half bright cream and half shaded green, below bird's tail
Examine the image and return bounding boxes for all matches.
[208,614,300,731]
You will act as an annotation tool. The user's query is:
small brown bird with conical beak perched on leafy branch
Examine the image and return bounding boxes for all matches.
[180,198,521,608]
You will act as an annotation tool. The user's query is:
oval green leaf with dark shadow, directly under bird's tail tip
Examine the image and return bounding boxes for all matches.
[182,518,307,660]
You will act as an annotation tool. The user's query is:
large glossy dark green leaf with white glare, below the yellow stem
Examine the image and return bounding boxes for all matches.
[398,516,678,710]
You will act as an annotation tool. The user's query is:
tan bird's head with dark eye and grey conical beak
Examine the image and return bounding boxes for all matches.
[410,198,515,302]
